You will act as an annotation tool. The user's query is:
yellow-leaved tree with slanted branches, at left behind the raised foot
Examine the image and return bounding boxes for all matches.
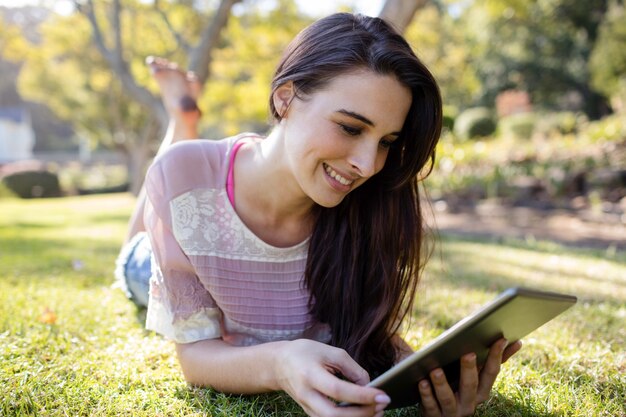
[3,0,240,191]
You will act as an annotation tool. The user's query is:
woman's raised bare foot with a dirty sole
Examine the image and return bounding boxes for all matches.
[146,56,202,124]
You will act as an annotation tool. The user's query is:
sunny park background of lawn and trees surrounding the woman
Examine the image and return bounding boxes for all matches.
[0,0,626,416]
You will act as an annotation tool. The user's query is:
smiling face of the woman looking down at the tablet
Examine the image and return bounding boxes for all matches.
[275,70,412,207]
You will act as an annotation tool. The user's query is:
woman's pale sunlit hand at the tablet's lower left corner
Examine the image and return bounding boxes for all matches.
[275,339,390,417]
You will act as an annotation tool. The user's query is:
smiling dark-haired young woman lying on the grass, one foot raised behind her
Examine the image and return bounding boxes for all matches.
[118,14,520,417]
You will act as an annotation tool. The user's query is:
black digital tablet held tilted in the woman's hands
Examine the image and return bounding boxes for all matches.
[369,288,576,409]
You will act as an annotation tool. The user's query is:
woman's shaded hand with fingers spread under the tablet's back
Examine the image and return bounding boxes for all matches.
[419,339,522,417]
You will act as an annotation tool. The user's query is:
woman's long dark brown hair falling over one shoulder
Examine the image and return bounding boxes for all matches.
[270,13,442,376]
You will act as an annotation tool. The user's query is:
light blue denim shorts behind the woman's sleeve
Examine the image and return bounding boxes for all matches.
[115,232,152,307]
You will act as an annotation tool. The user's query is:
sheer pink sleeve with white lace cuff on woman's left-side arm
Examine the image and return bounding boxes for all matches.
[144,148,221,343]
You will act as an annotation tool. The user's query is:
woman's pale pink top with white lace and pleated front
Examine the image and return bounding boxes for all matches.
[144,135,330,345]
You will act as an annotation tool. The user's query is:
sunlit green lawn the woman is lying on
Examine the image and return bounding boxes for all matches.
[0,194,626,416]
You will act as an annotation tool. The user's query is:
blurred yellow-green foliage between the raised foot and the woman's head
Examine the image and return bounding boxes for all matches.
[200,0,312,138]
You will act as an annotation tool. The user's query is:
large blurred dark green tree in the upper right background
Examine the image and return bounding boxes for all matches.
[460,0,607,117]
